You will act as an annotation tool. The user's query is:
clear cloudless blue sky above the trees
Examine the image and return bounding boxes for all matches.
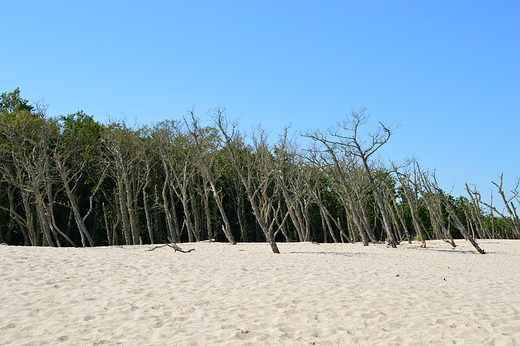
[0,0,520,207]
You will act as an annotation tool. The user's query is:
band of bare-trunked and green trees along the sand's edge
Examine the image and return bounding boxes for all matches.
[0,89,520,253]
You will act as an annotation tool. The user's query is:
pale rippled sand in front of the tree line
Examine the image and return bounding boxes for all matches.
[0,240,520,345]
